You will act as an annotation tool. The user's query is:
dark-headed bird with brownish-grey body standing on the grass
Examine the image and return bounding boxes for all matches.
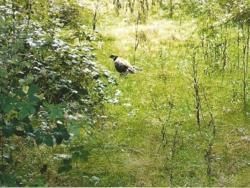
[110,55,136,74]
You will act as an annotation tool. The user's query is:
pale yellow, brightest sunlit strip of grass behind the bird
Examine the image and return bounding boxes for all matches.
[103,20,196,52]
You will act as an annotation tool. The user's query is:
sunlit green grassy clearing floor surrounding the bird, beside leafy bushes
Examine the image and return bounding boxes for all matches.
[87,11,250,186]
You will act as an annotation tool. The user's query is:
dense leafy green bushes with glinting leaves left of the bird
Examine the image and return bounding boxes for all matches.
[0,0,115,186]
